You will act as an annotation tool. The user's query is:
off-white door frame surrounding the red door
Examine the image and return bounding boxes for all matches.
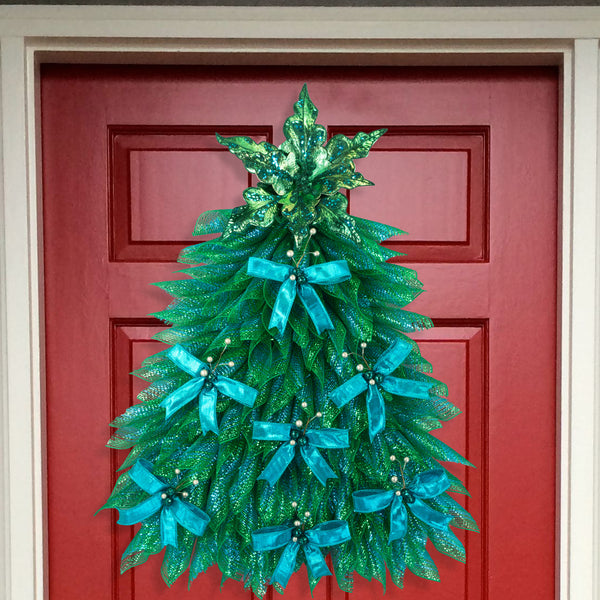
[0,6,600,600]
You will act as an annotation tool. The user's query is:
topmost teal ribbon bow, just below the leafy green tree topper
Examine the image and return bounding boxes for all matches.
[248,257,352,335]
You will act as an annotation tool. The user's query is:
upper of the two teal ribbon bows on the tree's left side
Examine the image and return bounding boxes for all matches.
[160,344,258,435]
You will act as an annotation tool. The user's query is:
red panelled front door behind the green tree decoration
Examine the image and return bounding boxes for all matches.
[42,65,557,600]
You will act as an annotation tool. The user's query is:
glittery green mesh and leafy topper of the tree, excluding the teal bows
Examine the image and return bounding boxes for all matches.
[104,84,477,596]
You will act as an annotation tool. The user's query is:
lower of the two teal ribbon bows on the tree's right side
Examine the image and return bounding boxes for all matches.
[352,469,452,542]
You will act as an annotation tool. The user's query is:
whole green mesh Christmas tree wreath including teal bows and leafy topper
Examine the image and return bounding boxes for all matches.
[99,86,477,596]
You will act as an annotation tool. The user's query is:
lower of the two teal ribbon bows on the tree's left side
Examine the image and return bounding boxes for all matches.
[117,458,210,548]
